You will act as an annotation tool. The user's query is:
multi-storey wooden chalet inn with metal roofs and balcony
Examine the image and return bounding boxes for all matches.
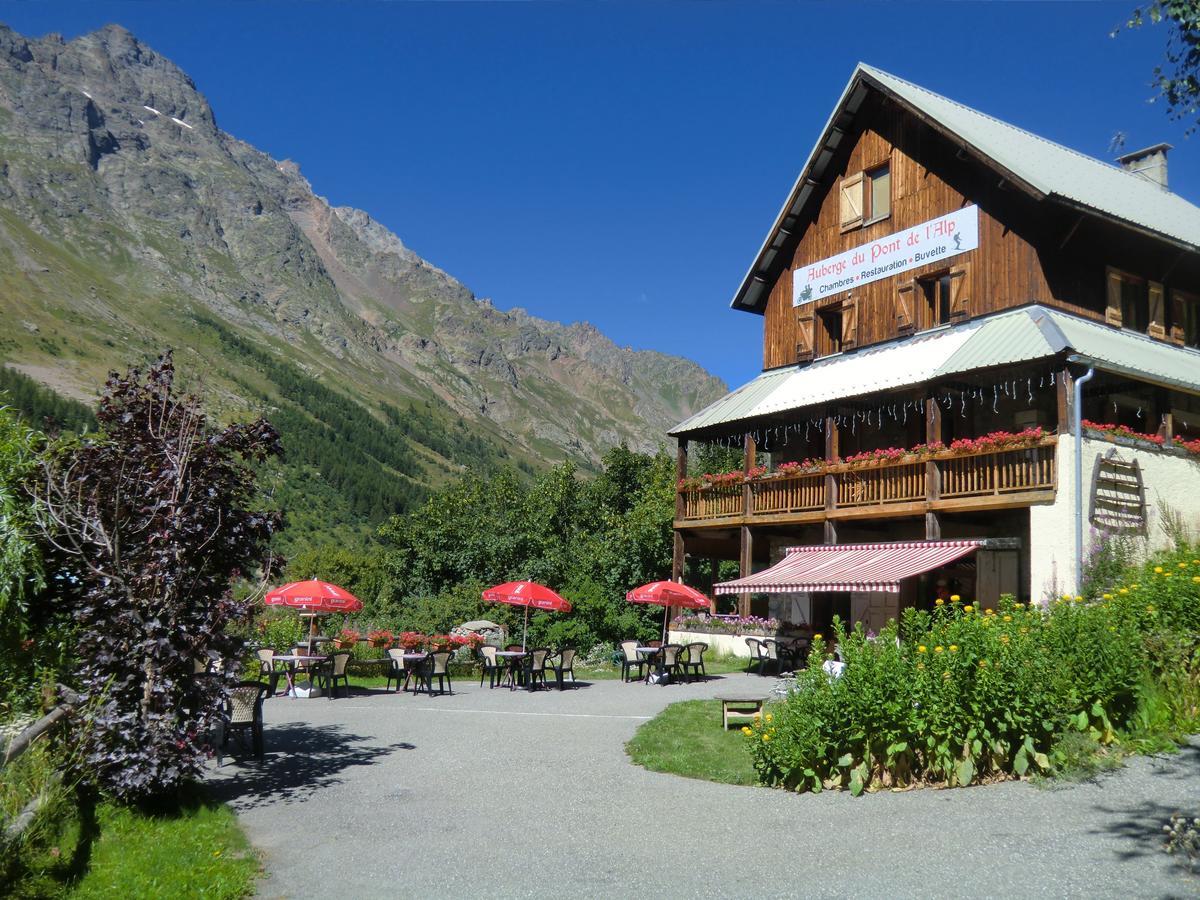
[671,65,1200,626]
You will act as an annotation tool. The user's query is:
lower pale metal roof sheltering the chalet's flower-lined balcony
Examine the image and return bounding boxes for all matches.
[670,304,1200,437]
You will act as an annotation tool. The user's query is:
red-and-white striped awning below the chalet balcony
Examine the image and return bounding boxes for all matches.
[713,540,985,594]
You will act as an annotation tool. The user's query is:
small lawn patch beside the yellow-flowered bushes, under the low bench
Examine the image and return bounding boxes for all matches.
[625,700,758,785]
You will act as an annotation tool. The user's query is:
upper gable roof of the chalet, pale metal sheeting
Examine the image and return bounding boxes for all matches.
[731,62,1200,313]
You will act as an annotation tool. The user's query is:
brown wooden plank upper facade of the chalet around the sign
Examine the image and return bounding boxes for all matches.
[763,94,1200,368]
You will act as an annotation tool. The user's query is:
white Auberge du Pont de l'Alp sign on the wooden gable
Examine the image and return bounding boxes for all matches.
[792,205,979,306]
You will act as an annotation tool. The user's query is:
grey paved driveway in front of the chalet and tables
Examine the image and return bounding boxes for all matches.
[212,674,1200,899]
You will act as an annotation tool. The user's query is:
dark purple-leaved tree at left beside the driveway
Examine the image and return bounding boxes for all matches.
[37,353,281,800]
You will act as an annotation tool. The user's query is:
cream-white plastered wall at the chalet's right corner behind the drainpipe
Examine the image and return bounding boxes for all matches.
[1030,434,1200,600]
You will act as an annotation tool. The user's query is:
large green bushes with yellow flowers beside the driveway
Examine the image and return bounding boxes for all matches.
[744,564,1200,794]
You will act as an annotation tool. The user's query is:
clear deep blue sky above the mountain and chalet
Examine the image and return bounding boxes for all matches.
[0,0,1200,385]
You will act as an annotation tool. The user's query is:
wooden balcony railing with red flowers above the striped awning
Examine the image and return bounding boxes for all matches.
[676,434,1057,528]
